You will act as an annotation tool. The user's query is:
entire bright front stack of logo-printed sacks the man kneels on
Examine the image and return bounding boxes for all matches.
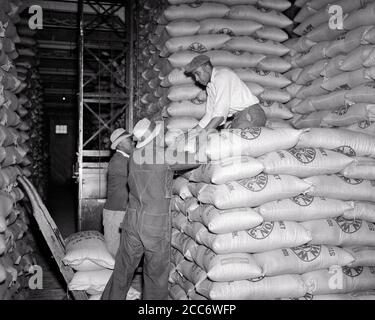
[170,128,375,300]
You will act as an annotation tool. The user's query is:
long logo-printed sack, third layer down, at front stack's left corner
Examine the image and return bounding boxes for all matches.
[197,173,311,209]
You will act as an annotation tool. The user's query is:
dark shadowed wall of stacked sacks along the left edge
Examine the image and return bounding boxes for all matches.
[0,0,40,300]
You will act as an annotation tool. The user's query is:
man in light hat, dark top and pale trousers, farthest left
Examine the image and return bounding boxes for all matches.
[103,128,133,256]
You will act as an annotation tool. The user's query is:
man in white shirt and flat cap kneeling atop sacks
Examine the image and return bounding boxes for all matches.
[185,55,266,132]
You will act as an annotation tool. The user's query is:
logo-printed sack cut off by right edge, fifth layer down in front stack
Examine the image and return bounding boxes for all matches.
[300,217,375,247]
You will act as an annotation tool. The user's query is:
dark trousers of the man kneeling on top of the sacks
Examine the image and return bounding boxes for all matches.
[230,104,267,129]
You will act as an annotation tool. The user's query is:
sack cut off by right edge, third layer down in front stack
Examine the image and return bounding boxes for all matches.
[305,174,375,202]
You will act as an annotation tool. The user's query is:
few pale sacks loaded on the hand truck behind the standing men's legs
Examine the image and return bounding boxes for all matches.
[63,231,141,300]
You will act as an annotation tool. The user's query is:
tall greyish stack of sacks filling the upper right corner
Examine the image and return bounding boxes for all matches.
[285,0,375,134]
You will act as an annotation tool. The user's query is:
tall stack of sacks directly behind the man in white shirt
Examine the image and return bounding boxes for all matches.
[141,0,293,141]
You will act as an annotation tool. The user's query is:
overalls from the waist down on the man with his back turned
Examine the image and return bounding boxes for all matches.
[102,209,171,300]
